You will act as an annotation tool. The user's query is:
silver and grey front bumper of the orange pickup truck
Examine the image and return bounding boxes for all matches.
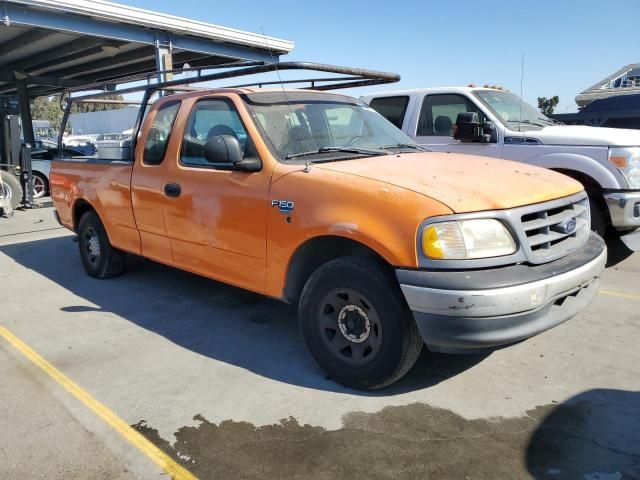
[397,234,607,353]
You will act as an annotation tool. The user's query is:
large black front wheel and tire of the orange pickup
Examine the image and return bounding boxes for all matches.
[298,257,423,390]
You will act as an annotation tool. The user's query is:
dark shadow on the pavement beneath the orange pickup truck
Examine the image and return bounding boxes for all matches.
[0,237,486,396]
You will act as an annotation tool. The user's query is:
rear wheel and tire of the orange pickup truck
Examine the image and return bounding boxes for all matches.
[78,212,126,279]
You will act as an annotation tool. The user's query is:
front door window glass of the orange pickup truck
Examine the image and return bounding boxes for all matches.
[180,99,258,168]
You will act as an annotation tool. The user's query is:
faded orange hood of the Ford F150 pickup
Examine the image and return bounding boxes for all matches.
[312,152,582,213]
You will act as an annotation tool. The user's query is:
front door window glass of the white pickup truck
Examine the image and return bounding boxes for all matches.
[416,94,484,137]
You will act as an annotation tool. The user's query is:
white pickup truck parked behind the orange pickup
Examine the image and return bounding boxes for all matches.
[361,87,640,250]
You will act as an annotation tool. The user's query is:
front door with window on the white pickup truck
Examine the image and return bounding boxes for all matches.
[415,93,502,157]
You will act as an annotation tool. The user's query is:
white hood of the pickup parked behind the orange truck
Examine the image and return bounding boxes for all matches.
[523,125,640,147]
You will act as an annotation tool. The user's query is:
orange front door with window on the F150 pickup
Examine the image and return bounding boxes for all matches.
[163,97,271,292]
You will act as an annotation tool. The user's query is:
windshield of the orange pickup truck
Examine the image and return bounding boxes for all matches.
[244,92,420,162]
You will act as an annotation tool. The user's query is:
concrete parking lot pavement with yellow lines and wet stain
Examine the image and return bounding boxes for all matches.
[0,203,640,480]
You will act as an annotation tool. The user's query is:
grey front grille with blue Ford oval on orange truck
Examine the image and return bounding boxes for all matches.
[520,195,590,263]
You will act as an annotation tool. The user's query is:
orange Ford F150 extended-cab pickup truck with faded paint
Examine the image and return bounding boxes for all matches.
[51,67,606,389]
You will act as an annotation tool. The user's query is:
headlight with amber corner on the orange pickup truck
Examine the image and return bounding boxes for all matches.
[422,218,516,260]
